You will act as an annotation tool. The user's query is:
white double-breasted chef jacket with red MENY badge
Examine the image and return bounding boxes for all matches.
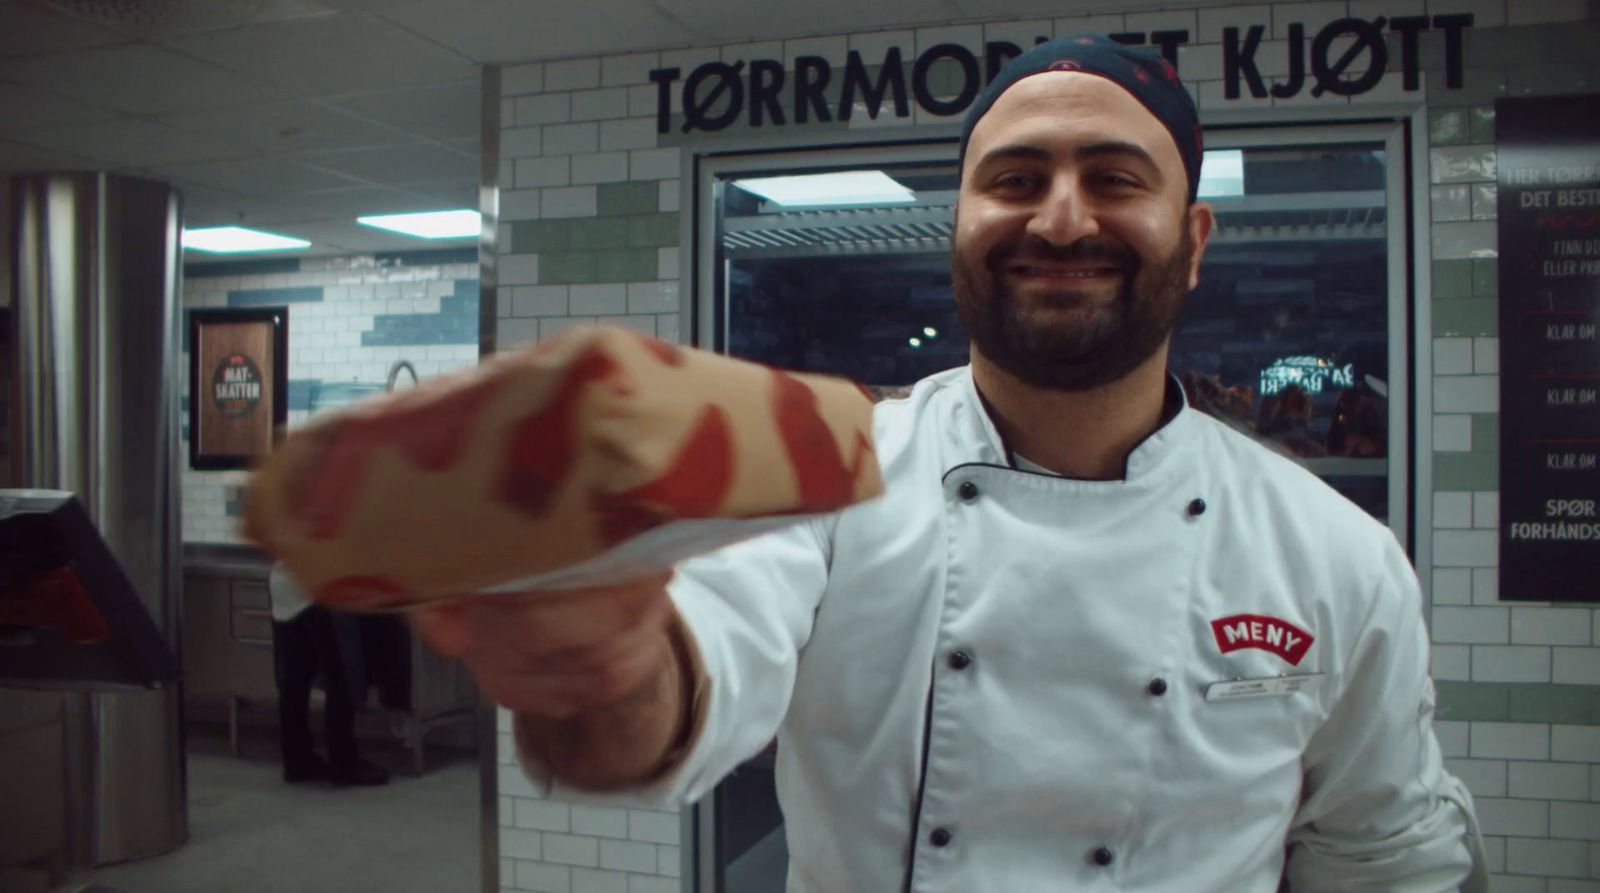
[530,368,1472,893]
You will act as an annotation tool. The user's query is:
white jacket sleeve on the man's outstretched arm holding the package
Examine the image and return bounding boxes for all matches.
[517,515,837,810]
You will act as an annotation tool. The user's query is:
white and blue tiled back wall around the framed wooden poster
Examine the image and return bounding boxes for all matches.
[179,253,478,543]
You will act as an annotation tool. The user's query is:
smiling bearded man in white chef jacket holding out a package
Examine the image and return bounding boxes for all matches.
[419,35,1478,893]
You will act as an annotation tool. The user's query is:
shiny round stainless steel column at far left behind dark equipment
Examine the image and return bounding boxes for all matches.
[8,173,189,866]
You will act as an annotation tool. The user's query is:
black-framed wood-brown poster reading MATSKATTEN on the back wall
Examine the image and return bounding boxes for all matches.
[189,307,290,471]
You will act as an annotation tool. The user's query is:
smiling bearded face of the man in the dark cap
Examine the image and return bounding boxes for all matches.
[950,72,1211,390]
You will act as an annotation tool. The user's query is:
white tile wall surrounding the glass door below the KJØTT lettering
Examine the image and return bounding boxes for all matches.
[498,0,1600,893]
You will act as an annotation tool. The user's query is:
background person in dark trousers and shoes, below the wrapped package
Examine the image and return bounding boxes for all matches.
[267,562,389,787]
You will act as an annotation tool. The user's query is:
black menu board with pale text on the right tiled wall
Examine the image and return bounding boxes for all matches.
[1494,96,1600,602]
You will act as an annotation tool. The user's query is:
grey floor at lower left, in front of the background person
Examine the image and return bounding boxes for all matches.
[59,735,482,893]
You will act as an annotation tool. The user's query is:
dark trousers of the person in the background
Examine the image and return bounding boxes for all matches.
[272,605,357,770]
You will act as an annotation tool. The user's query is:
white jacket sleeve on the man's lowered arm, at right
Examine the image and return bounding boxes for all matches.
[1286,539,1483,893]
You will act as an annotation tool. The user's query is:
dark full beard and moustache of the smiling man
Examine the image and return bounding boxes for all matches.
[950,227,1194,390]
